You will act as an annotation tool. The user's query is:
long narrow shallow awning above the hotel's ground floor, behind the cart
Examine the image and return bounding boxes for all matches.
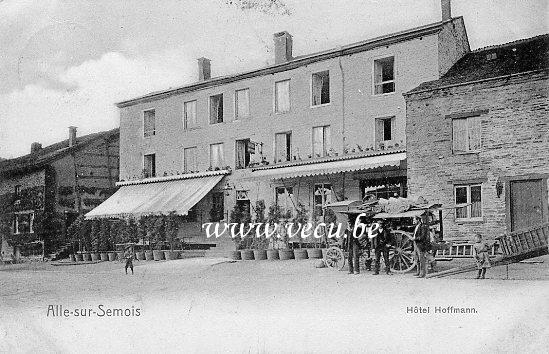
[251,152,406,179]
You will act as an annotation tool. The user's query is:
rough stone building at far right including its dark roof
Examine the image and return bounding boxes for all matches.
[405,35,549,239]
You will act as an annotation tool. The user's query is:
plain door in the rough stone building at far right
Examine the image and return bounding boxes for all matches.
[510,179,543,231]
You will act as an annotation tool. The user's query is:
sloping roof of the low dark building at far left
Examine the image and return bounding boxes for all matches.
[0,128,120,175]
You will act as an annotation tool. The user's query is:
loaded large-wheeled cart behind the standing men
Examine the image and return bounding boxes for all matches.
[324,196,445,273]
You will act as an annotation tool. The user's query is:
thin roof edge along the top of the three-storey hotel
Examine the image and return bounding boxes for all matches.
[116,16,463,108]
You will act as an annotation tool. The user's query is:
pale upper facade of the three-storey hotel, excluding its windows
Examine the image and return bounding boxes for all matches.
[120,34,438,179]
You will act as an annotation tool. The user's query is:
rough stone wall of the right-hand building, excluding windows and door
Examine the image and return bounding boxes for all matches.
[406,73,549,239]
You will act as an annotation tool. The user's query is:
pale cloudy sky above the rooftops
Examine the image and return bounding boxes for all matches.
[0,0,549,158]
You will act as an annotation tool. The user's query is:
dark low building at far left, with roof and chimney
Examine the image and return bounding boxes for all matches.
[0,127,119,258]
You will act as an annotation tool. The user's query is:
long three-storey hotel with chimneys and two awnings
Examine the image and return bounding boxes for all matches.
[88,1,470,252]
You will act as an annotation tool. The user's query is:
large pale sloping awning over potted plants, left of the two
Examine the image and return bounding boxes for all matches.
[86,171,228,219]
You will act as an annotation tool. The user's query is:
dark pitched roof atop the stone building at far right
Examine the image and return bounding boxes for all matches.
[405,34,549,95]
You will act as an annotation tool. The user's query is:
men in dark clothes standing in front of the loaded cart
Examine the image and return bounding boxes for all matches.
[345,215,431,278]
